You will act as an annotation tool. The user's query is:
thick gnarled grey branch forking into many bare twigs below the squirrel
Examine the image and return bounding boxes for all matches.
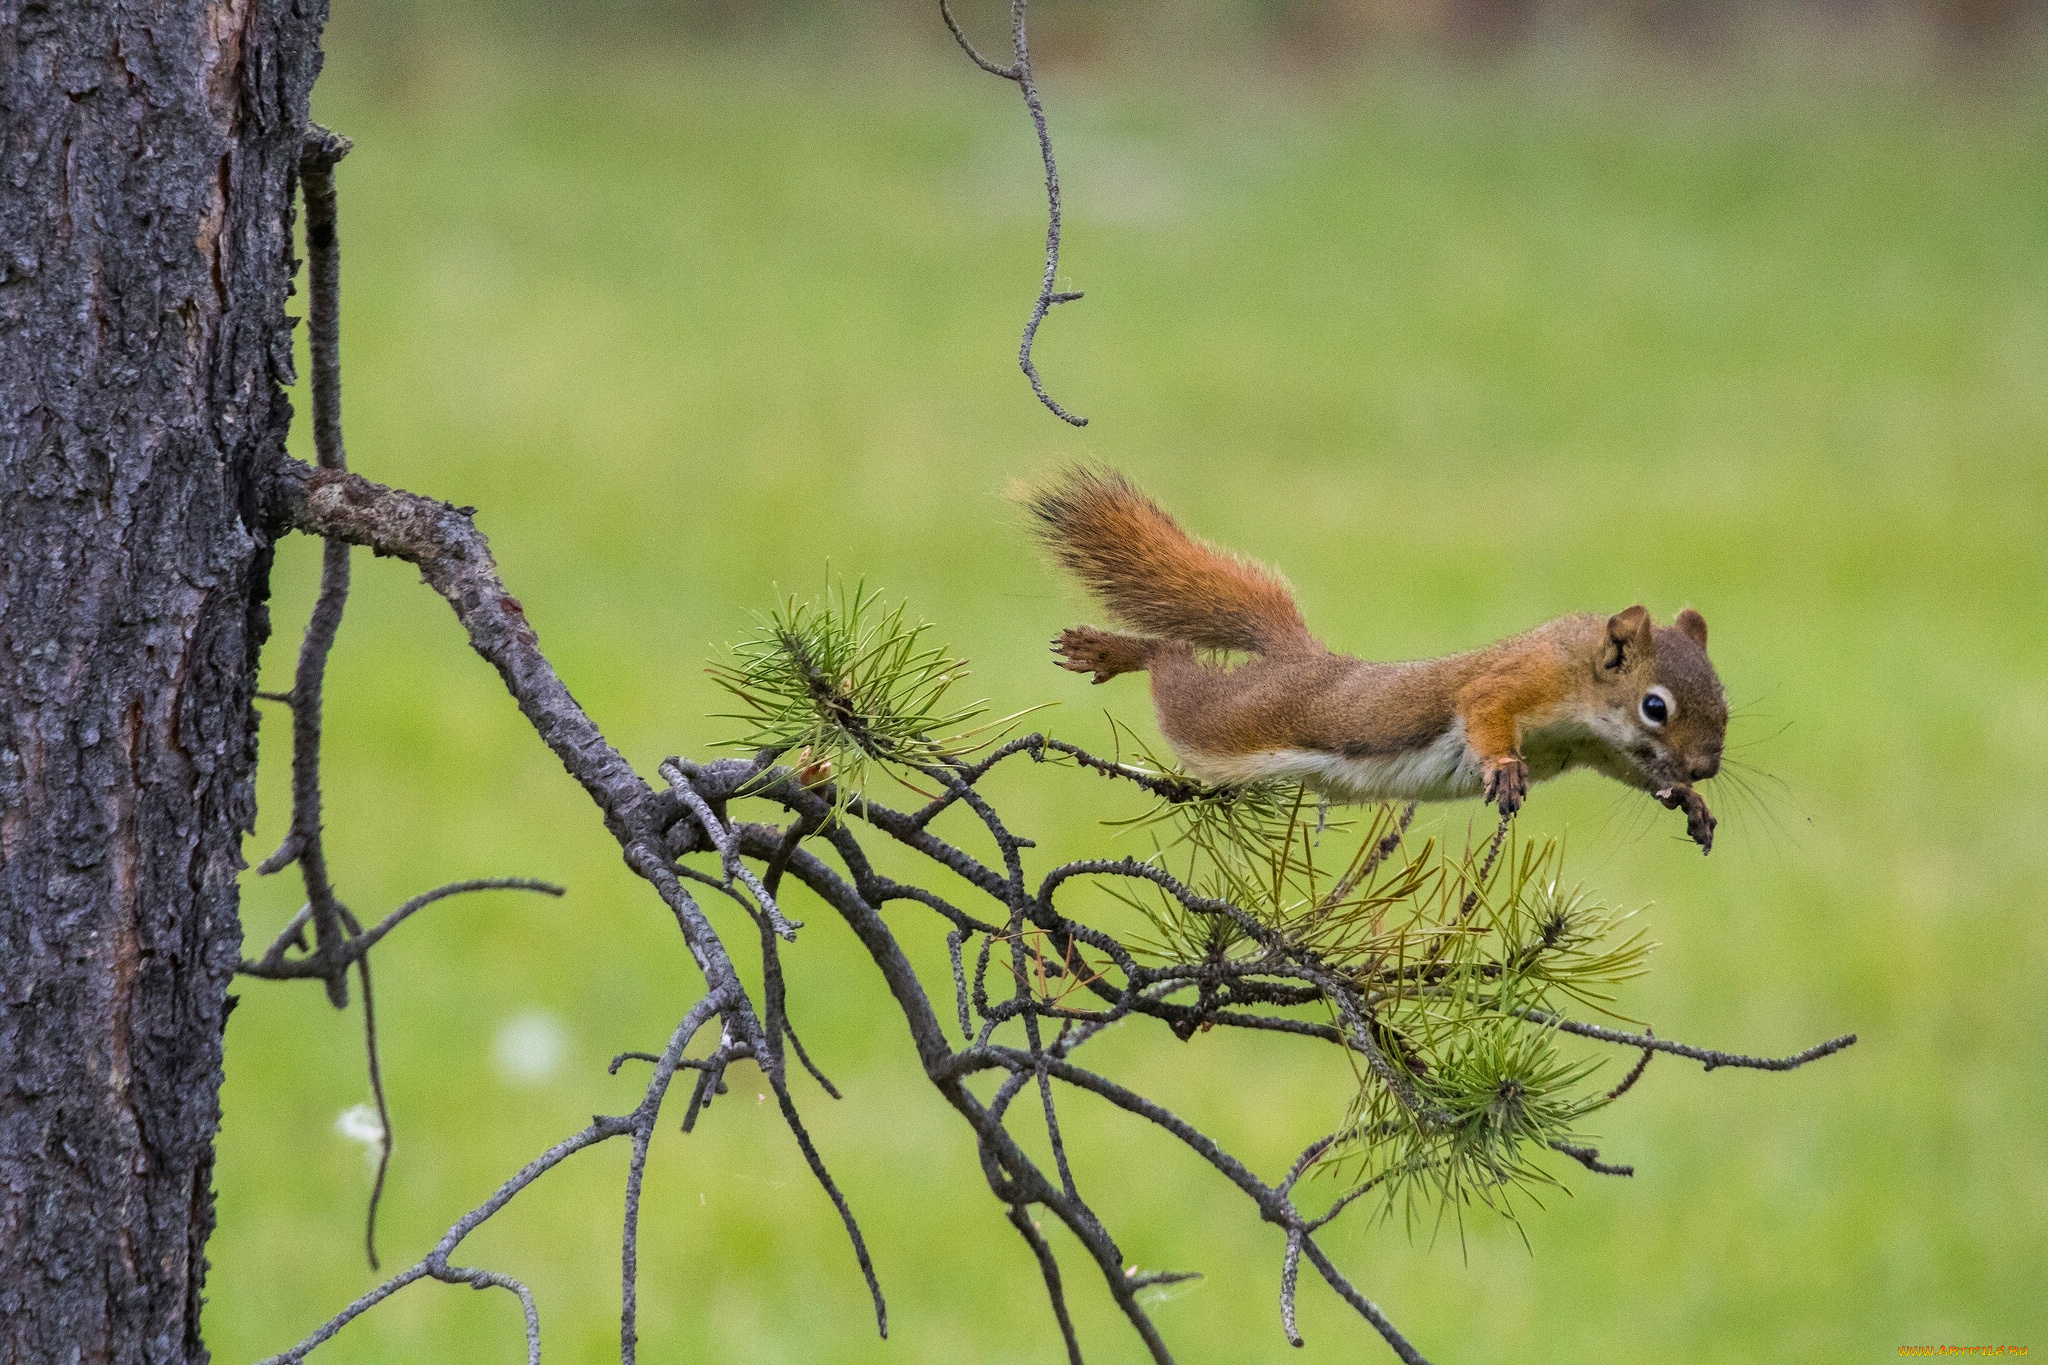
[250,450,1849,1361]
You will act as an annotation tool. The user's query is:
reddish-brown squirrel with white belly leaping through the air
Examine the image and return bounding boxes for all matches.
[1016,467,1729,853]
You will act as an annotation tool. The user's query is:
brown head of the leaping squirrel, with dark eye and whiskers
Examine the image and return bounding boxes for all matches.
[1595,606,1729,790]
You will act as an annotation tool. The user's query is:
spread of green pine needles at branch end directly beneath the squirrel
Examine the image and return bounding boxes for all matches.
[1110,740,1651,1226]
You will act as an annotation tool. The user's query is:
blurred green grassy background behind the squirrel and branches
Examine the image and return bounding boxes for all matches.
[205,0,2048,1365]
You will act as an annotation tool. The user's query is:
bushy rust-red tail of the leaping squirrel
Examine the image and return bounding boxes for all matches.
[1020,467,1309,653]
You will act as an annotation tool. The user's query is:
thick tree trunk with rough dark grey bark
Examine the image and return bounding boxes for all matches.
[0,0,326,1363]
